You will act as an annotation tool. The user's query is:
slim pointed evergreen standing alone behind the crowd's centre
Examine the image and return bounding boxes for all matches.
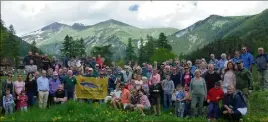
[125,38,136,62]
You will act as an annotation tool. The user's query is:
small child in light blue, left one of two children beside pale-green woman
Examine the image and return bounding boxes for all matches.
[175,85,185,117]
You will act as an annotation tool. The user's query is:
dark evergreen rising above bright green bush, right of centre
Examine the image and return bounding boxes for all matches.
[156,33,172,51]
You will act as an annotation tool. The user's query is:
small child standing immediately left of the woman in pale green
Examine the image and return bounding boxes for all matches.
[183,85,191,116]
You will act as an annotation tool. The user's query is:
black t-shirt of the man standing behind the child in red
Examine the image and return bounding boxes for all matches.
[204,72,221,91]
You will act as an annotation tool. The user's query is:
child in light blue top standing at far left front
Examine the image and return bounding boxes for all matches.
[3,88,15,115]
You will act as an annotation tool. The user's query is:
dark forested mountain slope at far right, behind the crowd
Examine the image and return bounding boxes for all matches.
[185,9,268,60]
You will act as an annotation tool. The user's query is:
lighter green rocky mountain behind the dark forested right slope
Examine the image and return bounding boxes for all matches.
[168,15,252,55]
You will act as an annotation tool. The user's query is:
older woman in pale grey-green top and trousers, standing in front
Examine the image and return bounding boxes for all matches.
[190,69,207,116]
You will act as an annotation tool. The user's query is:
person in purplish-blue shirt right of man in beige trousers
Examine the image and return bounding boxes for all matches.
[48,71,61,106]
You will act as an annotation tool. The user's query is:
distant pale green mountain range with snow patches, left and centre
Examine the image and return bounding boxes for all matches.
[21,19,178,58]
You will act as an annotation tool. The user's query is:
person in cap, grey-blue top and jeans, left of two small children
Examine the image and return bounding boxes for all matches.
[161,74,175,111]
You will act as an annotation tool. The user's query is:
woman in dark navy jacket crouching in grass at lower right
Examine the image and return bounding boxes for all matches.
[222,85,247,121]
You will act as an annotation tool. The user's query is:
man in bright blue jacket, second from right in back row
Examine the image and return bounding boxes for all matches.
[241,46,254,71]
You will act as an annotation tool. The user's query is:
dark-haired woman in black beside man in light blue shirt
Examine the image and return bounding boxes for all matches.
[25,73,37,106]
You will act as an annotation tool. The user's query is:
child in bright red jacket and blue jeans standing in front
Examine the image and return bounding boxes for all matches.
[207,82,224,121]
